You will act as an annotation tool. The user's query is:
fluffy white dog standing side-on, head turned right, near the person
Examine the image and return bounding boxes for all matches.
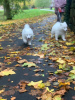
[51,22,67,41]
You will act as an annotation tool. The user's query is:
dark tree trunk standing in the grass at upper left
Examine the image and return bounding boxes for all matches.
[4,0,12,20]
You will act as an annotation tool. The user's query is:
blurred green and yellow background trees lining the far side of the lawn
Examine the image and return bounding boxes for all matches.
[0,0,51,20]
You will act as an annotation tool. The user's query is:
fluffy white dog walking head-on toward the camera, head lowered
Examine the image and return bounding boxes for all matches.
[22,24,33,45]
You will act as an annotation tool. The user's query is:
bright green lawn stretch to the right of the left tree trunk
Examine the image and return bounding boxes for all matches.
[13,9,52,19]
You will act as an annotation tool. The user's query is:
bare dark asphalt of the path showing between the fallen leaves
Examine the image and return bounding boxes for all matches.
[0,15,75,100]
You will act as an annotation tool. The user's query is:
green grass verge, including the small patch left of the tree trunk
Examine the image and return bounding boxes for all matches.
[0,9,53,21]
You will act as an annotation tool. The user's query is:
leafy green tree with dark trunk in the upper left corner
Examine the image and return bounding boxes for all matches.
[0,0,30,20]
